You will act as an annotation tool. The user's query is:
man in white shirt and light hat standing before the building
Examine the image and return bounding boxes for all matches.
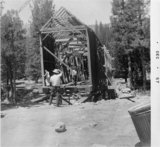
[49,69,63,107]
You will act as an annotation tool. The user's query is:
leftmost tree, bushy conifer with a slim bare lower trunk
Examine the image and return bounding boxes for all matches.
[2,10,25,103]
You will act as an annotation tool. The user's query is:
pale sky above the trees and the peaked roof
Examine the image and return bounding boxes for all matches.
[3,0,112,25]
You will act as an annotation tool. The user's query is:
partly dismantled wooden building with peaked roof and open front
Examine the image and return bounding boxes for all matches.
[40,7,112,101]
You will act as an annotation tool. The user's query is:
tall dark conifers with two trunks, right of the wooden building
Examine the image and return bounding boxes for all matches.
[111,0,150,89]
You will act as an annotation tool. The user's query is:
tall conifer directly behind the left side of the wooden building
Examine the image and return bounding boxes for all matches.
[26,0,54,82]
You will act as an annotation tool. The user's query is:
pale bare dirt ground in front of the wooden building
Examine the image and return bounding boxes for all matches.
[1,91,150,147]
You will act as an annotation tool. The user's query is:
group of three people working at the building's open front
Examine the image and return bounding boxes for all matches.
[44,69,77,107]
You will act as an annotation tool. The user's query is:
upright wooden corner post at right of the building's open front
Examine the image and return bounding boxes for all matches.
[86,29,93,85]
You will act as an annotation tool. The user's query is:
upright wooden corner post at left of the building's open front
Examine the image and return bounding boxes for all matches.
[39,33,45,86]
